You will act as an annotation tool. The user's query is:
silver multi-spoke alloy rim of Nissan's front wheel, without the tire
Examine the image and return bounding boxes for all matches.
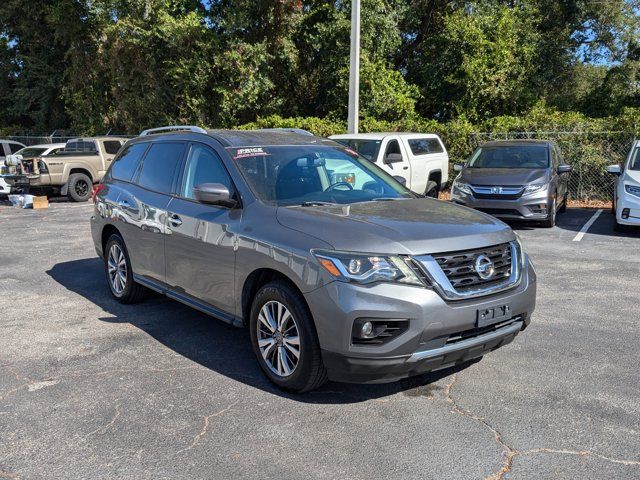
[257,301,300,377]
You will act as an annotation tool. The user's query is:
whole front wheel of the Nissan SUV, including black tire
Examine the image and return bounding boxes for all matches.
[249,281,327,393]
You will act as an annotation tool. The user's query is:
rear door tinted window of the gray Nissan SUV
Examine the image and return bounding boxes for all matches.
[138,142,185,194]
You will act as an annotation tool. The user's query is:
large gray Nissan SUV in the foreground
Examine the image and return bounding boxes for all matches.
[91,127,536,392]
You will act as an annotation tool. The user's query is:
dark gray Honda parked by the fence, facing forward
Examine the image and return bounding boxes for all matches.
[451,140,571,227]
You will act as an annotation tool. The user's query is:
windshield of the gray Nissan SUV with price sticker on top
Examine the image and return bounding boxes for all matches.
[229,145,414,206]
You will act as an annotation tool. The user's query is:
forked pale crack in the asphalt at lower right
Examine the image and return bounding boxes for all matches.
[445,373,640,480]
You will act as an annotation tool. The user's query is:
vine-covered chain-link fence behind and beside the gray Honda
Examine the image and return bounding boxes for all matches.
[469,132,635,201]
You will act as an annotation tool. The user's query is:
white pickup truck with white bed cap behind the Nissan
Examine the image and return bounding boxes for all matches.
[329,132,449,198]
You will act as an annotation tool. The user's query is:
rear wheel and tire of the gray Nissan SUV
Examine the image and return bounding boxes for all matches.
[104,234,145,304]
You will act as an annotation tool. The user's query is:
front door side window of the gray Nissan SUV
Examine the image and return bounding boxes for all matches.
[180,144,233,199]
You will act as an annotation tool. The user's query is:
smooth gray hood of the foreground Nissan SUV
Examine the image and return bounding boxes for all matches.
[276,198,515,255]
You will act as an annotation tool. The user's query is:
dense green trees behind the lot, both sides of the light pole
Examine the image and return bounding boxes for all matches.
[0,0,640,133]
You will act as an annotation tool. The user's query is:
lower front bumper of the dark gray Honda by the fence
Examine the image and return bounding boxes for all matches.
[451,191,562,221]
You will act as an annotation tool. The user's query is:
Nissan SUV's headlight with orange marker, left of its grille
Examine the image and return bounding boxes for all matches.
[311,250,424,286]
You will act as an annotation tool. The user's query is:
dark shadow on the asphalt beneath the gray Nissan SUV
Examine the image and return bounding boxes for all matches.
[47,258,475,404]
